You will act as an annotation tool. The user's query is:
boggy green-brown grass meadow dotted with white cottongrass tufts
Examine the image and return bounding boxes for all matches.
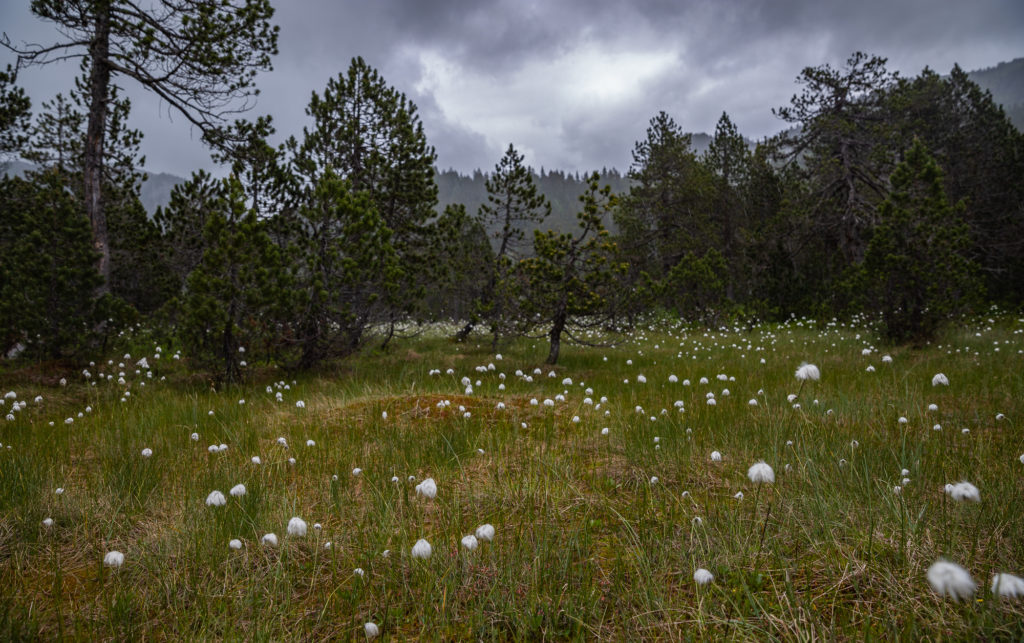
[0,313,1024,641]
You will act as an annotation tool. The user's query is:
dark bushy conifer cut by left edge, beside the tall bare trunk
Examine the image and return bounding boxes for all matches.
[0,171,100,357]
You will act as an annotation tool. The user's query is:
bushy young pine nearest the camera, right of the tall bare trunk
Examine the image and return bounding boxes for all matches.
[180,178,294,382]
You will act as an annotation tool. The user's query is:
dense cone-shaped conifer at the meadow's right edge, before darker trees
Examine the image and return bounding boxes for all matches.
[863,140,977,342]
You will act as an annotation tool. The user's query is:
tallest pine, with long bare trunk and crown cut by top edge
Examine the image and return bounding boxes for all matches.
[0,0,278,293]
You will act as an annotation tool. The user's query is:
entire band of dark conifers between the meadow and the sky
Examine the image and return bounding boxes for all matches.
[0,0,1024,381]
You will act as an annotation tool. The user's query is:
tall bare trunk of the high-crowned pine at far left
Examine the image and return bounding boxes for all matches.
[82,3,111,295]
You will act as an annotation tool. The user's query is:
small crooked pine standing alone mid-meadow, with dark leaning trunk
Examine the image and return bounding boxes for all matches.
[518,172,627,363]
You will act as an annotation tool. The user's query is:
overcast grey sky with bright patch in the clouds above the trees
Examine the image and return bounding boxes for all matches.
[0,0,1024,176]
